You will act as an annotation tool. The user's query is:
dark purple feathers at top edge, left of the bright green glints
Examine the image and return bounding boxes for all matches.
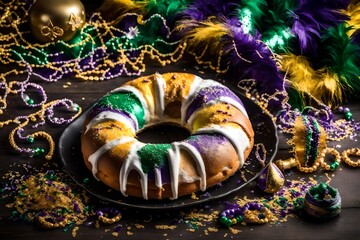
[182,0,238,21]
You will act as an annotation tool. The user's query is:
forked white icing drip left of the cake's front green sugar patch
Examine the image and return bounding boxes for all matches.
[119,142,148,199]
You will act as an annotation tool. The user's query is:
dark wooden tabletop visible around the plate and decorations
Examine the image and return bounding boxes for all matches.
[0,62,360,240]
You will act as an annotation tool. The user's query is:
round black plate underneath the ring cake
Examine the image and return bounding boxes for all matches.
[59,90,278,209]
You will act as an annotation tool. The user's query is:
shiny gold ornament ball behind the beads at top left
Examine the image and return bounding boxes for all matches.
[30,0,85,43]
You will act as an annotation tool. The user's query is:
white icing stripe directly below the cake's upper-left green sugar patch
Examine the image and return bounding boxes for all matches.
[85,111,139,134]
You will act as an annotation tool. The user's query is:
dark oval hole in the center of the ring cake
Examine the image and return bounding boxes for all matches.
[137,123,190,143]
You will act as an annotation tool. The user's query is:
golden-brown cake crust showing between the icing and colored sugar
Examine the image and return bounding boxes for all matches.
[81,73,254,199]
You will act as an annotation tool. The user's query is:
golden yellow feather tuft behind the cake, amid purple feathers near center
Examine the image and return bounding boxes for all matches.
[176,19,230,54]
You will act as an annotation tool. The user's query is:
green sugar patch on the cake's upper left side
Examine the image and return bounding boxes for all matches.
[98,92,145,128]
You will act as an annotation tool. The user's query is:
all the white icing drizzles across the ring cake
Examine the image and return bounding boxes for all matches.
[85,73,250,199]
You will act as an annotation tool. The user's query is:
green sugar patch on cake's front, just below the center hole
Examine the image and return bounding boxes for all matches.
[137,144,171,173]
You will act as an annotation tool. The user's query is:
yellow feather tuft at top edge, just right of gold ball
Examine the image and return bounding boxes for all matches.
[98,0,148,25]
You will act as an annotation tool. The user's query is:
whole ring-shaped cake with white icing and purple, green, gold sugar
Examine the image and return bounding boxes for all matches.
[81,73,254,199]
